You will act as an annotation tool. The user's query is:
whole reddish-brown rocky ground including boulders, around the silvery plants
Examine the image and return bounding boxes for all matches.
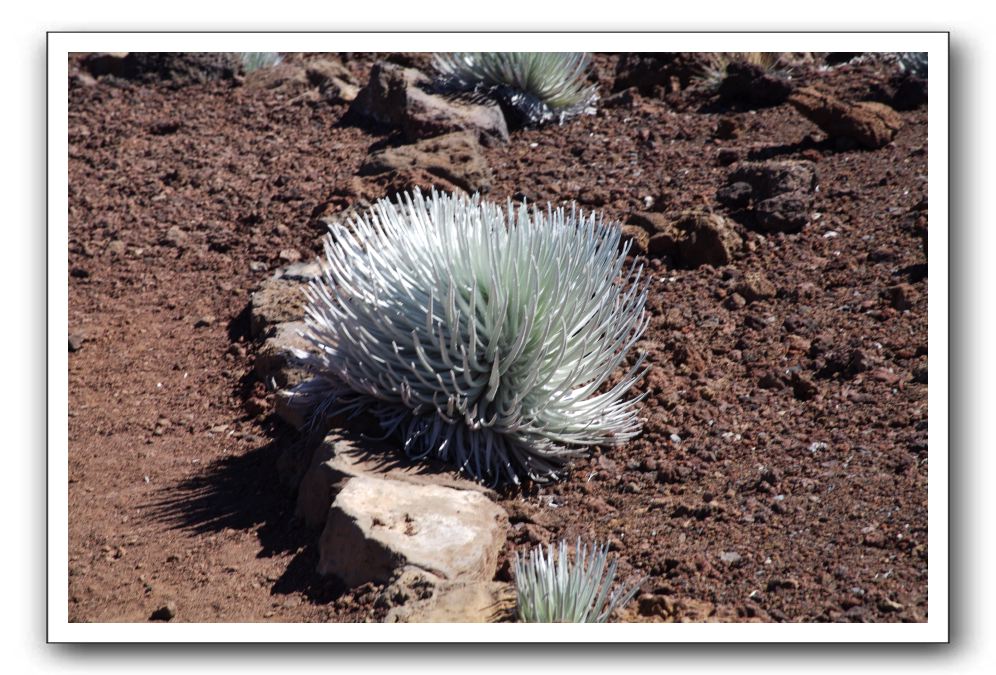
[68,54,928,621]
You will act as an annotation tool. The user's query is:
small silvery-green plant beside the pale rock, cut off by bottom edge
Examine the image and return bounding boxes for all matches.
[515,538,639,623]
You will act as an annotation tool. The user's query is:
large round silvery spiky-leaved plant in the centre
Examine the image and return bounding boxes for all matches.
[295,190,648,484]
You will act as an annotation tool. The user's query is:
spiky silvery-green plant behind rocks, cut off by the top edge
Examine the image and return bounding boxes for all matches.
[433,52,598,126]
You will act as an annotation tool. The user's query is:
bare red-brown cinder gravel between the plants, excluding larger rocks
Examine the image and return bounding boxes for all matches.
[68,54,927,622]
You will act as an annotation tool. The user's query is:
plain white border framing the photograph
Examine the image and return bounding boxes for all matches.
[47,31,950,643]
